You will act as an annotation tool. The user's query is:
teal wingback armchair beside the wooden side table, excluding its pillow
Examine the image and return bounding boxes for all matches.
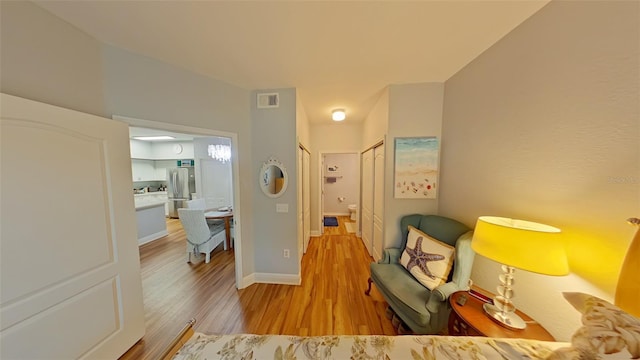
[365,214,475,334]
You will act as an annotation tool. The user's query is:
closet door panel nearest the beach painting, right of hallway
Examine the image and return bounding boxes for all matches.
[373,145,384,260]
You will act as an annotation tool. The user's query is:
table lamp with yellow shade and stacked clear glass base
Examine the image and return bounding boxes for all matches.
[471,216,569,329]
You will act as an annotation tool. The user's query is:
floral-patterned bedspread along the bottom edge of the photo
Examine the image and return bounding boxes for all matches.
[174,333,567,360]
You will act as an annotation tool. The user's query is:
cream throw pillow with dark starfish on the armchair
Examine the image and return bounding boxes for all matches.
[400,226,455,290]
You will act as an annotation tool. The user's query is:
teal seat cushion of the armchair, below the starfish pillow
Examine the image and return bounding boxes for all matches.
[371,263,431,326]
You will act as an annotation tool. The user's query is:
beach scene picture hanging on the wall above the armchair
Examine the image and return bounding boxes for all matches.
[394,136,439,199]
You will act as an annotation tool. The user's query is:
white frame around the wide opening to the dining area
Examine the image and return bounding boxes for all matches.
[112,115,244,289]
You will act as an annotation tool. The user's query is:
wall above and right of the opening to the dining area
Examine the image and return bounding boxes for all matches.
[0,1,254,274]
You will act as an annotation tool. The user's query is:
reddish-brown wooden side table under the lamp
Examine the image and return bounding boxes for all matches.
[449,291,555,341]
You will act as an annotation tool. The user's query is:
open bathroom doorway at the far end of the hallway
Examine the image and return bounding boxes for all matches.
[320,152,360,233]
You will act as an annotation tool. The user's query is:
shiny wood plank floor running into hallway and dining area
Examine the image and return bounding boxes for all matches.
[121,216,396,359]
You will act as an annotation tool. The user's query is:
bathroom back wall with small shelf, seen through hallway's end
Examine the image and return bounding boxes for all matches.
[322,153,360,215]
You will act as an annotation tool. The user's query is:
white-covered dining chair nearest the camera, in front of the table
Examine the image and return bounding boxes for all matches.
[178,208,224,263]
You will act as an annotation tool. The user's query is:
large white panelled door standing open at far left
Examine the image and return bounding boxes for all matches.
[0,94,144,359]
